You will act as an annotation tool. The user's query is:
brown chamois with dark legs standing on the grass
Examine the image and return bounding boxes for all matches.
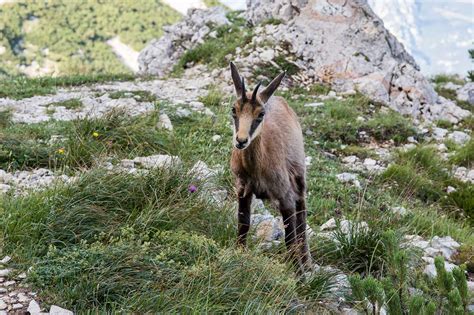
[230,62,311,272]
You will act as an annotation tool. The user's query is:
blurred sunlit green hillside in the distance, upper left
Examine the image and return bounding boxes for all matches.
[0,0,179,75]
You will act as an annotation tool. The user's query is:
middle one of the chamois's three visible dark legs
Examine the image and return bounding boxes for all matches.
[279,199,301,273]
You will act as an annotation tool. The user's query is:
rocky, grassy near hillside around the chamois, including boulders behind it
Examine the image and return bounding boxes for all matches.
[0,0,474,315]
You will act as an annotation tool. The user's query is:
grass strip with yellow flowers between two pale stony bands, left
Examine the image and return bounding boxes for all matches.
[0,111,172,170]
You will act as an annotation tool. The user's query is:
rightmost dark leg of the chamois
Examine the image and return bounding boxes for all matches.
[295,176,312,271]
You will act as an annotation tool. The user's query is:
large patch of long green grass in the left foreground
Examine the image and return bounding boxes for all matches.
[0,168,324,313]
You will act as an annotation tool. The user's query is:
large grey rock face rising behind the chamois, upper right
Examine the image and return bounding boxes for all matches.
[247,0,469,123]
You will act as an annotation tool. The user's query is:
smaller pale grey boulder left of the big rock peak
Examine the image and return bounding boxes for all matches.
[138,7,229,76]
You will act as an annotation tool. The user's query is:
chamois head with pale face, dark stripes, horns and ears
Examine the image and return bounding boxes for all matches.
[230,62,285,150]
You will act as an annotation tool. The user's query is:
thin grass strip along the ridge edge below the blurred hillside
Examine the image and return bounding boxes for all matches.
[0,74,135,99]
